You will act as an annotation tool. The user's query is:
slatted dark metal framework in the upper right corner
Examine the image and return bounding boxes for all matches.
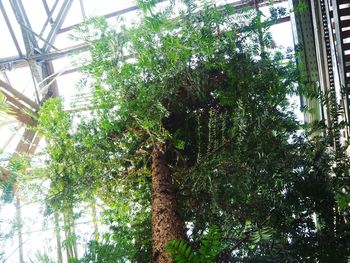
[290,0,350,148]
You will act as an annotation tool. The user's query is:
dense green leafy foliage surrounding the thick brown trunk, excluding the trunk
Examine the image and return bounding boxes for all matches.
[31,1,350,262]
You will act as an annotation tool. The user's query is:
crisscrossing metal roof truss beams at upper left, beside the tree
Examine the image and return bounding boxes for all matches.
[0,0,289,162]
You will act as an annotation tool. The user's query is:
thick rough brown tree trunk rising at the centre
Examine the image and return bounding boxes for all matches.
[152,146,185,263]
